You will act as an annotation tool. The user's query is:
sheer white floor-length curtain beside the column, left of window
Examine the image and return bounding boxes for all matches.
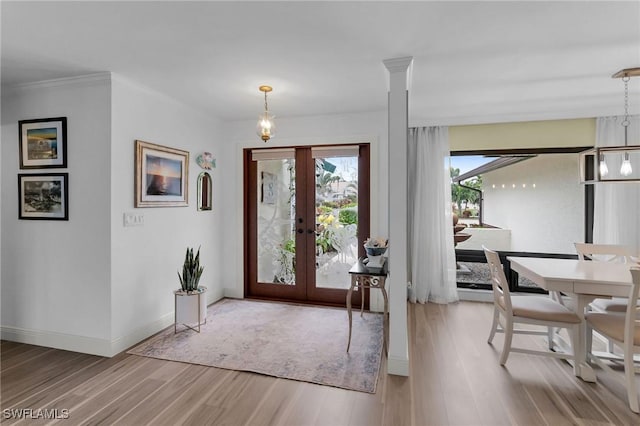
[407,127,458,303]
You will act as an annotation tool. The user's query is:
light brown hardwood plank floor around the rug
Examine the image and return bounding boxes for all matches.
[0,302,640,426]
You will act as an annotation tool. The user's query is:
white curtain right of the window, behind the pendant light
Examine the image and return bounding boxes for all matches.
[593,115,640,253]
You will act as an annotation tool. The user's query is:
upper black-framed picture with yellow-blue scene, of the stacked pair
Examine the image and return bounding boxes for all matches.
[18,117,67,169]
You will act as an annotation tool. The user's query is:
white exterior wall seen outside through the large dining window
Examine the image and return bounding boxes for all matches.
[482,154,584,254]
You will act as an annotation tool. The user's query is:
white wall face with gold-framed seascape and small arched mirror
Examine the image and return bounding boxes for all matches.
[110,76,226,350]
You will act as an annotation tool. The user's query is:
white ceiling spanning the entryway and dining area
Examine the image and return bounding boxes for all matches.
[1,1,640,125]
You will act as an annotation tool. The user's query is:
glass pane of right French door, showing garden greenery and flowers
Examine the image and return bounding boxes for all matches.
[315,156,358,289]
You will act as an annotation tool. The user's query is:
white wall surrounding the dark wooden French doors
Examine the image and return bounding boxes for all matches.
[219,111,388,300]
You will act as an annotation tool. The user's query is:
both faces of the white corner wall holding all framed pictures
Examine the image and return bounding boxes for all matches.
[0,73,224,356]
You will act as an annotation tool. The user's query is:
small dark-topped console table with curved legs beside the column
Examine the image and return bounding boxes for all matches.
[347,257,389,352]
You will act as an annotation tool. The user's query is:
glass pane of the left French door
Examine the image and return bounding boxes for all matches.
[257,158,296,285]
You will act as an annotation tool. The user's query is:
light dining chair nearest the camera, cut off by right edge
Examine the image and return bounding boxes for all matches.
[585,266,640,413]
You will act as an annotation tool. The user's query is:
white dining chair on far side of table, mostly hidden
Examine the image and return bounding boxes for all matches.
[574,243,637,354]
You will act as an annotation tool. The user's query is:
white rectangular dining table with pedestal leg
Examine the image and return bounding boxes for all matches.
[507,256,632,382]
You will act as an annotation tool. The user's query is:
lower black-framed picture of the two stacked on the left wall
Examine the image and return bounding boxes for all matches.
[18,173,69,220]
